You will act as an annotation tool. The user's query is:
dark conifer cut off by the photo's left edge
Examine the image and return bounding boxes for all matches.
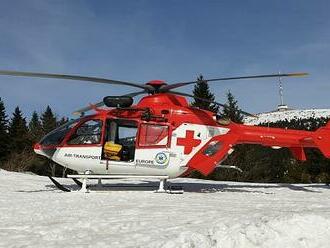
[0,98,9,162]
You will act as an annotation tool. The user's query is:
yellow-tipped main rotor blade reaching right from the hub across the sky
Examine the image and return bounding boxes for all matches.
[160,72,308,92]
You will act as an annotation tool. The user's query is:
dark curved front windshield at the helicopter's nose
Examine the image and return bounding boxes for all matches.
[39,118,81,146]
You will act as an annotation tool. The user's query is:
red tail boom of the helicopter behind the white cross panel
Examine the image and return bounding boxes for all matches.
[188,122,330,175]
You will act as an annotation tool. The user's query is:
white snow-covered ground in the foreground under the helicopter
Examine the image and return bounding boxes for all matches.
[0,170,330,248]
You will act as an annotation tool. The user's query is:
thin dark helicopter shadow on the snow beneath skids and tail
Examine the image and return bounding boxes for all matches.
[38,180,330,194]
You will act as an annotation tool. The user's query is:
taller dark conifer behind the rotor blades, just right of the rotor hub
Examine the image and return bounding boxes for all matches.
[191,75,219,113]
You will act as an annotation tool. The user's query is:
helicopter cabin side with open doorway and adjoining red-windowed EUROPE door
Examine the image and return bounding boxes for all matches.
[101,119,170,175]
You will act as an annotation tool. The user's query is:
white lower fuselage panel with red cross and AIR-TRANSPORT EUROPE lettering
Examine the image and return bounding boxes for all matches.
[52,123,229,178]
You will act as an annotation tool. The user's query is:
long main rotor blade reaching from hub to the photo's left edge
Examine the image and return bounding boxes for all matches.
[0,70,151,90]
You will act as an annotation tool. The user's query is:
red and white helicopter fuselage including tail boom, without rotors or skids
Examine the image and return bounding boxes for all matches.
[35,94,330,178]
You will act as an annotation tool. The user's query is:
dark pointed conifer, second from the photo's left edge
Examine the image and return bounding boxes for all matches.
[9,107,31,153]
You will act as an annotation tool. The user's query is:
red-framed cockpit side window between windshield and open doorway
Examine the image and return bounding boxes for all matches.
[67,120,102,145]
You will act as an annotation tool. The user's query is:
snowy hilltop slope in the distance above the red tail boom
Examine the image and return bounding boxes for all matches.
[244,109,330,125]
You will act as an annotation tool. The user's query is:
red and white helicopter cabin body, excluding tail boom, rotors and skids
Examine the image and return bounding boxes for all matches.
[35,94,229,178]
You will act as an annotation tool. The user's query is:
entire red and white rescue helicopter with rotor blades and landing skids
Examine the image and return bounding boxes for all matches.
[0,70,330,192]
